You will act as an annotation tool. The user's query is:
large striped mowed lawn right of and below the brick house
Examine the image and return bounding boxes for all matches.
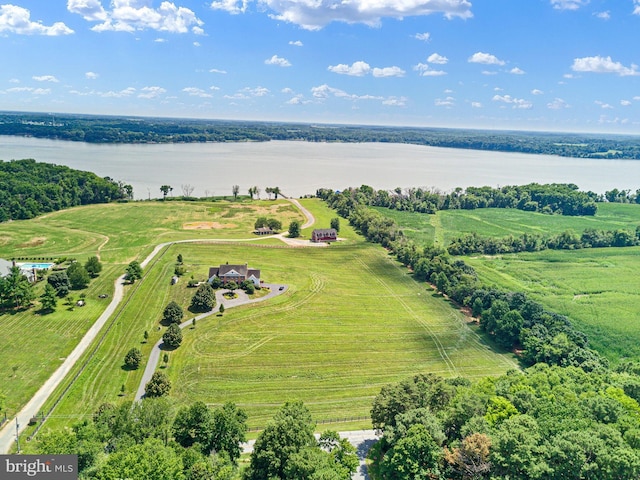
[166,243,516,427]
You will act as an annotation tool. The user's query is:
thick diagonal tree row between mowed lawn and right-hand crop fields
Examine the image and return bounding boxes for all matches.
[320,190,608,370]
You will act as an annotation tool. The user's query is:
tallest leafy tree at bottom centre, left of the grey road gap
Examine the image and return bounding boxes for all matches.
[244,401,317,480]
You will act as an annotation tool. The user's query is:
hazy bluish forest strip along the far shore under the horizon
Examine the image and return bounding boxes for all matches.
[0,112,640,159]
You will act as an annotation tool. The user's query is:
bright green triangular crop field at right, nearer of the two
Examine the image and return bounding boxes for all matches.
[466,247,640,362]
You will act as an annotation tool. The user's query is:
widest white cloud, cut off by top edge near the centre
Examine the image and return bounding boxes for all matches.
[238,0,473,30]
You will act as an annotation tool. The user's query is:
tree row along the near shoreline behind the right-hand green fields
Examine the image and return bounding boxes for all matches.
[316,183,600,215]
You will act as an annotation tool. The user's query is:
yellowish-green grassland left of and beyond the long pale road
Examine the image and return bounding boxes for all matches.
[0,201,303,414]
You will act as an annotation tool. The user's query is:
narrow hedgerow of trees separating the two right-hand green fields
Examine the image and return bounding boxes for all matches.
[447,226,640,255]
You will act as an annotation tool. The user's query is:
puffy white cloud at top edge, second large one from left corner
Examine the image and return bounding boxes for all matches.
[67,0,204,35]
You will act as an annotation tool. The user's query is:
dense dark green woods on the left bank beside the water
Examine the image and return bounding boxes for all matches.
[0,159,133,222]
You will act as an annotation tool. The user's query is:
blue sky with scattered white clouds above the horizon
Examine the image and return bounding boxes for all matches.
[0,0,640,133]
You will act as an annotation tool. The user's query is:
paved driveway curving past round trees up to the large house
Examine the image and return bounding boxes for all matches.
[135,283,289,401]
